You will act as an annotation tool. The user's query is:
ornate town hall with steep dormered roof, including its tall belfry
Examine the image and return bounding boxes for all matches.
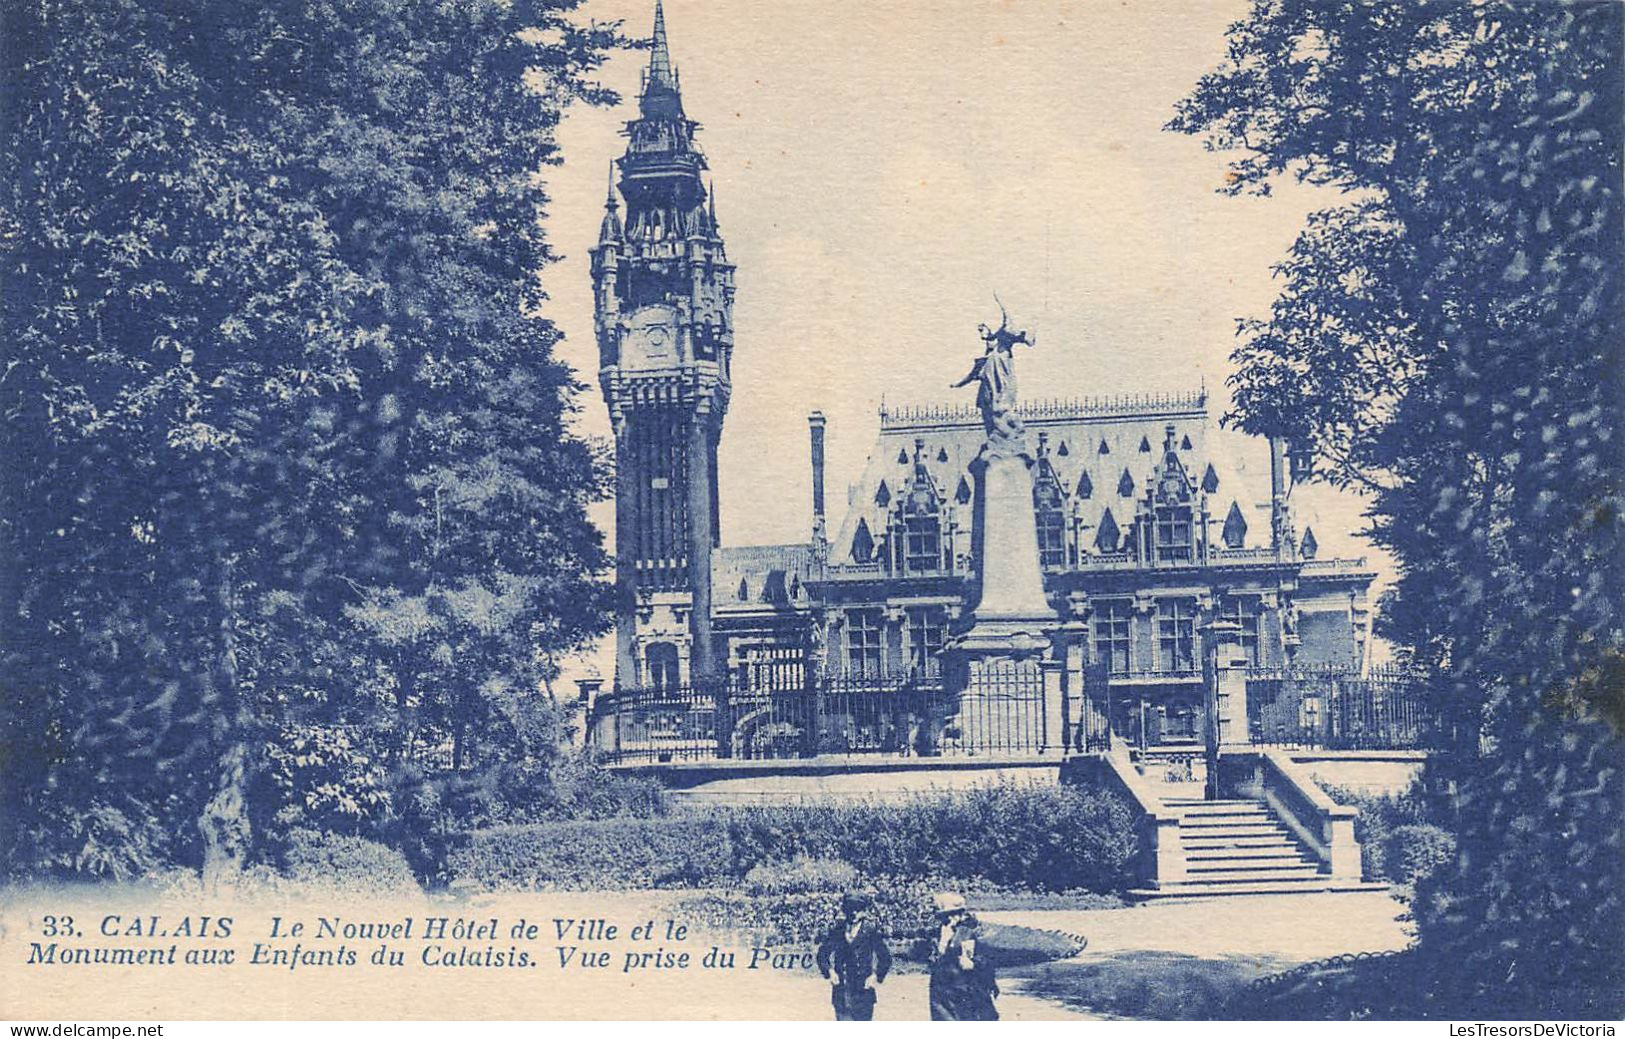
[592,3,1375,754]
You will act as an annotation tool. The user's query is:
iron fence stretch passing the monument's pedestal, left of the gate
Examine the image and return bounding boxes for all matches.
[590,667,1060,764]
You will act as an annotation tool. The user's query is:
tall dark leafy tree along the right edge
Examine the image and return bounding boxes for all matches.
[1170,0,1625,1016]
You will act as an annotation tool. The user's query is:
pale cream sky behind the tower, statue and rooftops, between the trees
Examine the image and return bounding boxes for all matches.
[546,0,1386,679]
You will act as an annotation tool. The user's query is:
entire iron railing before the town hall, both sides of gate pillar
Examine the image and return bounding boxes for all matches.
[590,660,1443,764]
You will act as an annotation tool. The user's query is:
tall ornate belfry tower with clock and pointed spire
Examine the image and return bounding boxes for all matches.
[592,0,733,686]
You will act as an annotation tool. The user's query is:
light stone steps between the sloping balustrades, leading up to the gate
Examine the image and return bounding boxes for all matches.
[1131,796,1385,899]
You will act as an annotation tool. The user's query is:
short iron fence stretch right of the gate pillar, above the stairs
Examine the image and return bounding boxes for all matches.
[1246,668,1441,750]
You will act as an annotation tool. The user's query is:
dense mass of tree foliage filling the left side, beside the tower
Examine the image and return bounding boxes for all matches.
[0,0,624,876]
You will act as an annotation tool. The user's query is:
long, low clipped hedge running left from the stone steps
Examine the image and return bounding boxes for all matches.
[447,784,1138,891]
